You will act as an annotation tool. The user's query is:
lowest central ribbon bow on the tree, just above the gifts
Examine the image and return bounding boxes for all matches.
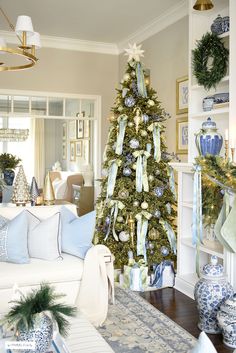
[135,210,152,261]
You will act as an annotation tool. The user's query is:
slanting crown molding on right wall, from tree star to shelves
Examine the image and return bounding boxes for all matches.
[117,0,188,54]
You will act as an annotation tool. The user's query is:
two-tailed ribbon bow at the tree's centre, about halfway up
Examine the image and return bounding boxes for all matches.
[133,150,150,192]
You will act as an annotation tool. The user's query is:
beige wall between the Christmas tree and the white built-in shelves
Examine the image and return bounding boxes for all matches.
[119,17,188,161]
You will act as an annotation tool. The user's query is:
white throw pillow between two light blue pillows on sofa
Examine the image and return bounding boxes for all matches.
[27,211,61,261]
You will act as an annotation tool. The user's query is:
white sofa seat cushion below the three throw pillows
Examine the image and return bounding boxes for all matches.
[0,254,84,289]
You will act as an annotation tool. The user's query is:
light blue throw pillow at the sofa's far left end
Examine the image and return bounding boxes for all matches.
[0,211,29,264]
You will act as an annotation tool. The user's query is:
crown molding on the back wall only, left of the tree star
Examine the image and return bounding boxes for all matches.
[0,31,119,55]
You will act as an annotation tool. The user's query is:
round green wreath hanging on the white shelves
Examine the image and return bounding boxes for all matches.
[192,32,229,90]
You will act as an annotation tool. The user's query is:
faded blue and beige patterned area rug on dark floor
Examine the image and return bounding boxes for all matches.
[98,287,196,353]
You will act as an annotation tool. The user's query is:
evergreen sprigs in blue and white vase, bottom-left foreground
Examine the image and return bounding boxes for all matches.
[3,283,77,353]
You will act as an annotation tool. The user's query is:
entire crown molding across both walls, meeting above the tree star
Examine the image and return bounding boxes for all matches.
[0,0,188,55]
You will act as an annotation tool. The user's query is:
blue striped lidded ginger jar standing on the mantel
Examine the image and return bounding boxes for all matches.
[195,117,223,156]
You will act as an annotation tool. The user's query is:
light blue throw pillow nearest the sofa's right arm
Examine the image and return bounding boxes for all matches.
[61,207,96,259]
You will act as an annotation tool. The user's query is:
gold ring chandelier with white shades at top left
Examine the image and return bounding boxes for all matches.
[0,7,41,71]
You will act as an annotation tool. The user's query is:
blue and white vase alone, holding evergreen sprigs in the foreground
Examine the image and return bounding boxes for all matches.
[17,312,53,353]
